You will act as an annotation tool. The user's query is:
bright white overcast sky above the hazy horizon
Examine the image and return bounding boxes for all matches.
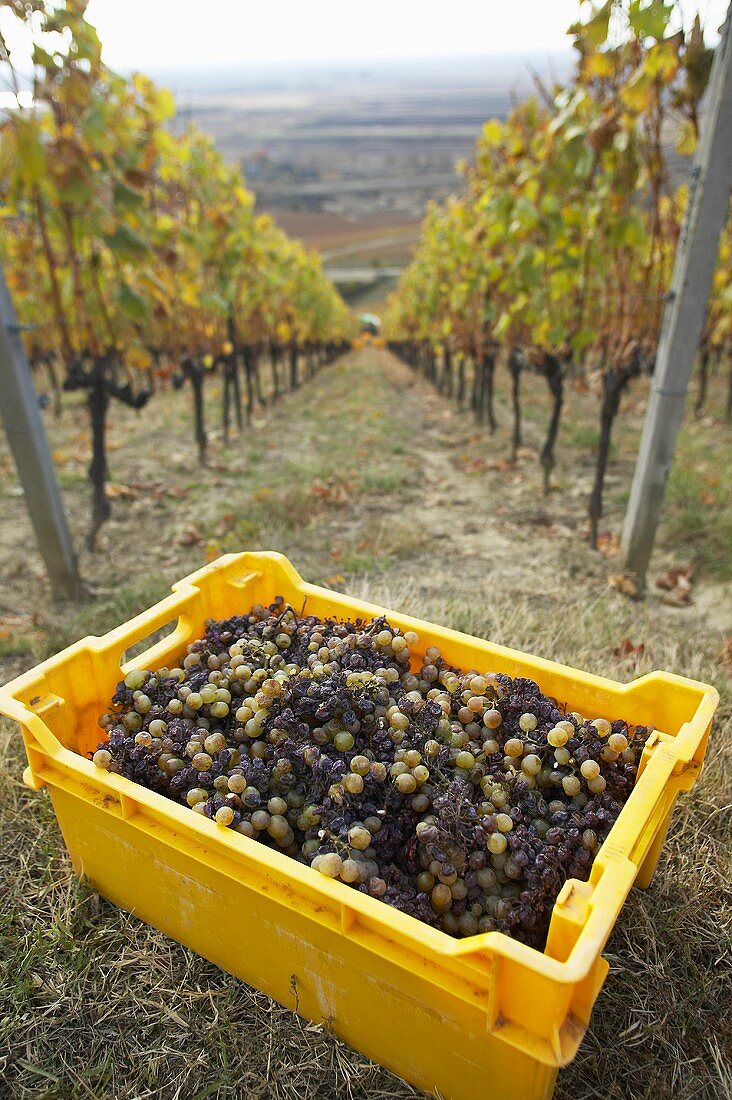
[79,0,726,70]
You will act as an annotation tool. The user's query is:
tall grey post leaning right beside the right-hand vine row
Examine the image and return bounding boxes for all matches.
[621,4,732,590]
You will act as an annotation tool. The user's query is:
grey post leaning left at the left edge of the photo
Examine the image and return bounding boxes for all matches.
[0,270,84,600]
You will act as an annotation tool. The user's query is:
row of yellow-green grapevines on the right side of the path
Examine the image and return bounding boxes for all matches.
[385,0,732,545]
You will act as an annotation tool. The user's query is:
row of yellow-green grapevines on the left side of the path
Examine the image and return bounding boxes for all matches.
[0,0,350,546]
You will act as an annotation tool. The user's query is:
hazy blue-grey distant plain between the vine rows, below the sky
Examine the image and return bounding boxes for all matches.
[161,54,569,218]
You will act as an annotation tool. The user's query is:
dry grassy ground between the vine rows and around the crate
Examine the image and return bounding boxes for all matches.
[0,349,732,1100]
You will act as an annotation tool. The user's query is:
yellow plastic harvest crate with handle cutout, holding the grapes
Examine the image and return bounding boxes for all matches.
[0,553,719,1100]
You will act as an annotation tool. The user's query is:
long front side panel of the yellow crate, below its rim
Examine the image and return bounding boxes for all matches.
[50,788,556,1100]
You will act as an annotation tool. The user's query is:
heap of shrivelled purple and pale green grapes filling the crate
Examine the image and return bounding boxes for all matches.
[94,597,648,949]
